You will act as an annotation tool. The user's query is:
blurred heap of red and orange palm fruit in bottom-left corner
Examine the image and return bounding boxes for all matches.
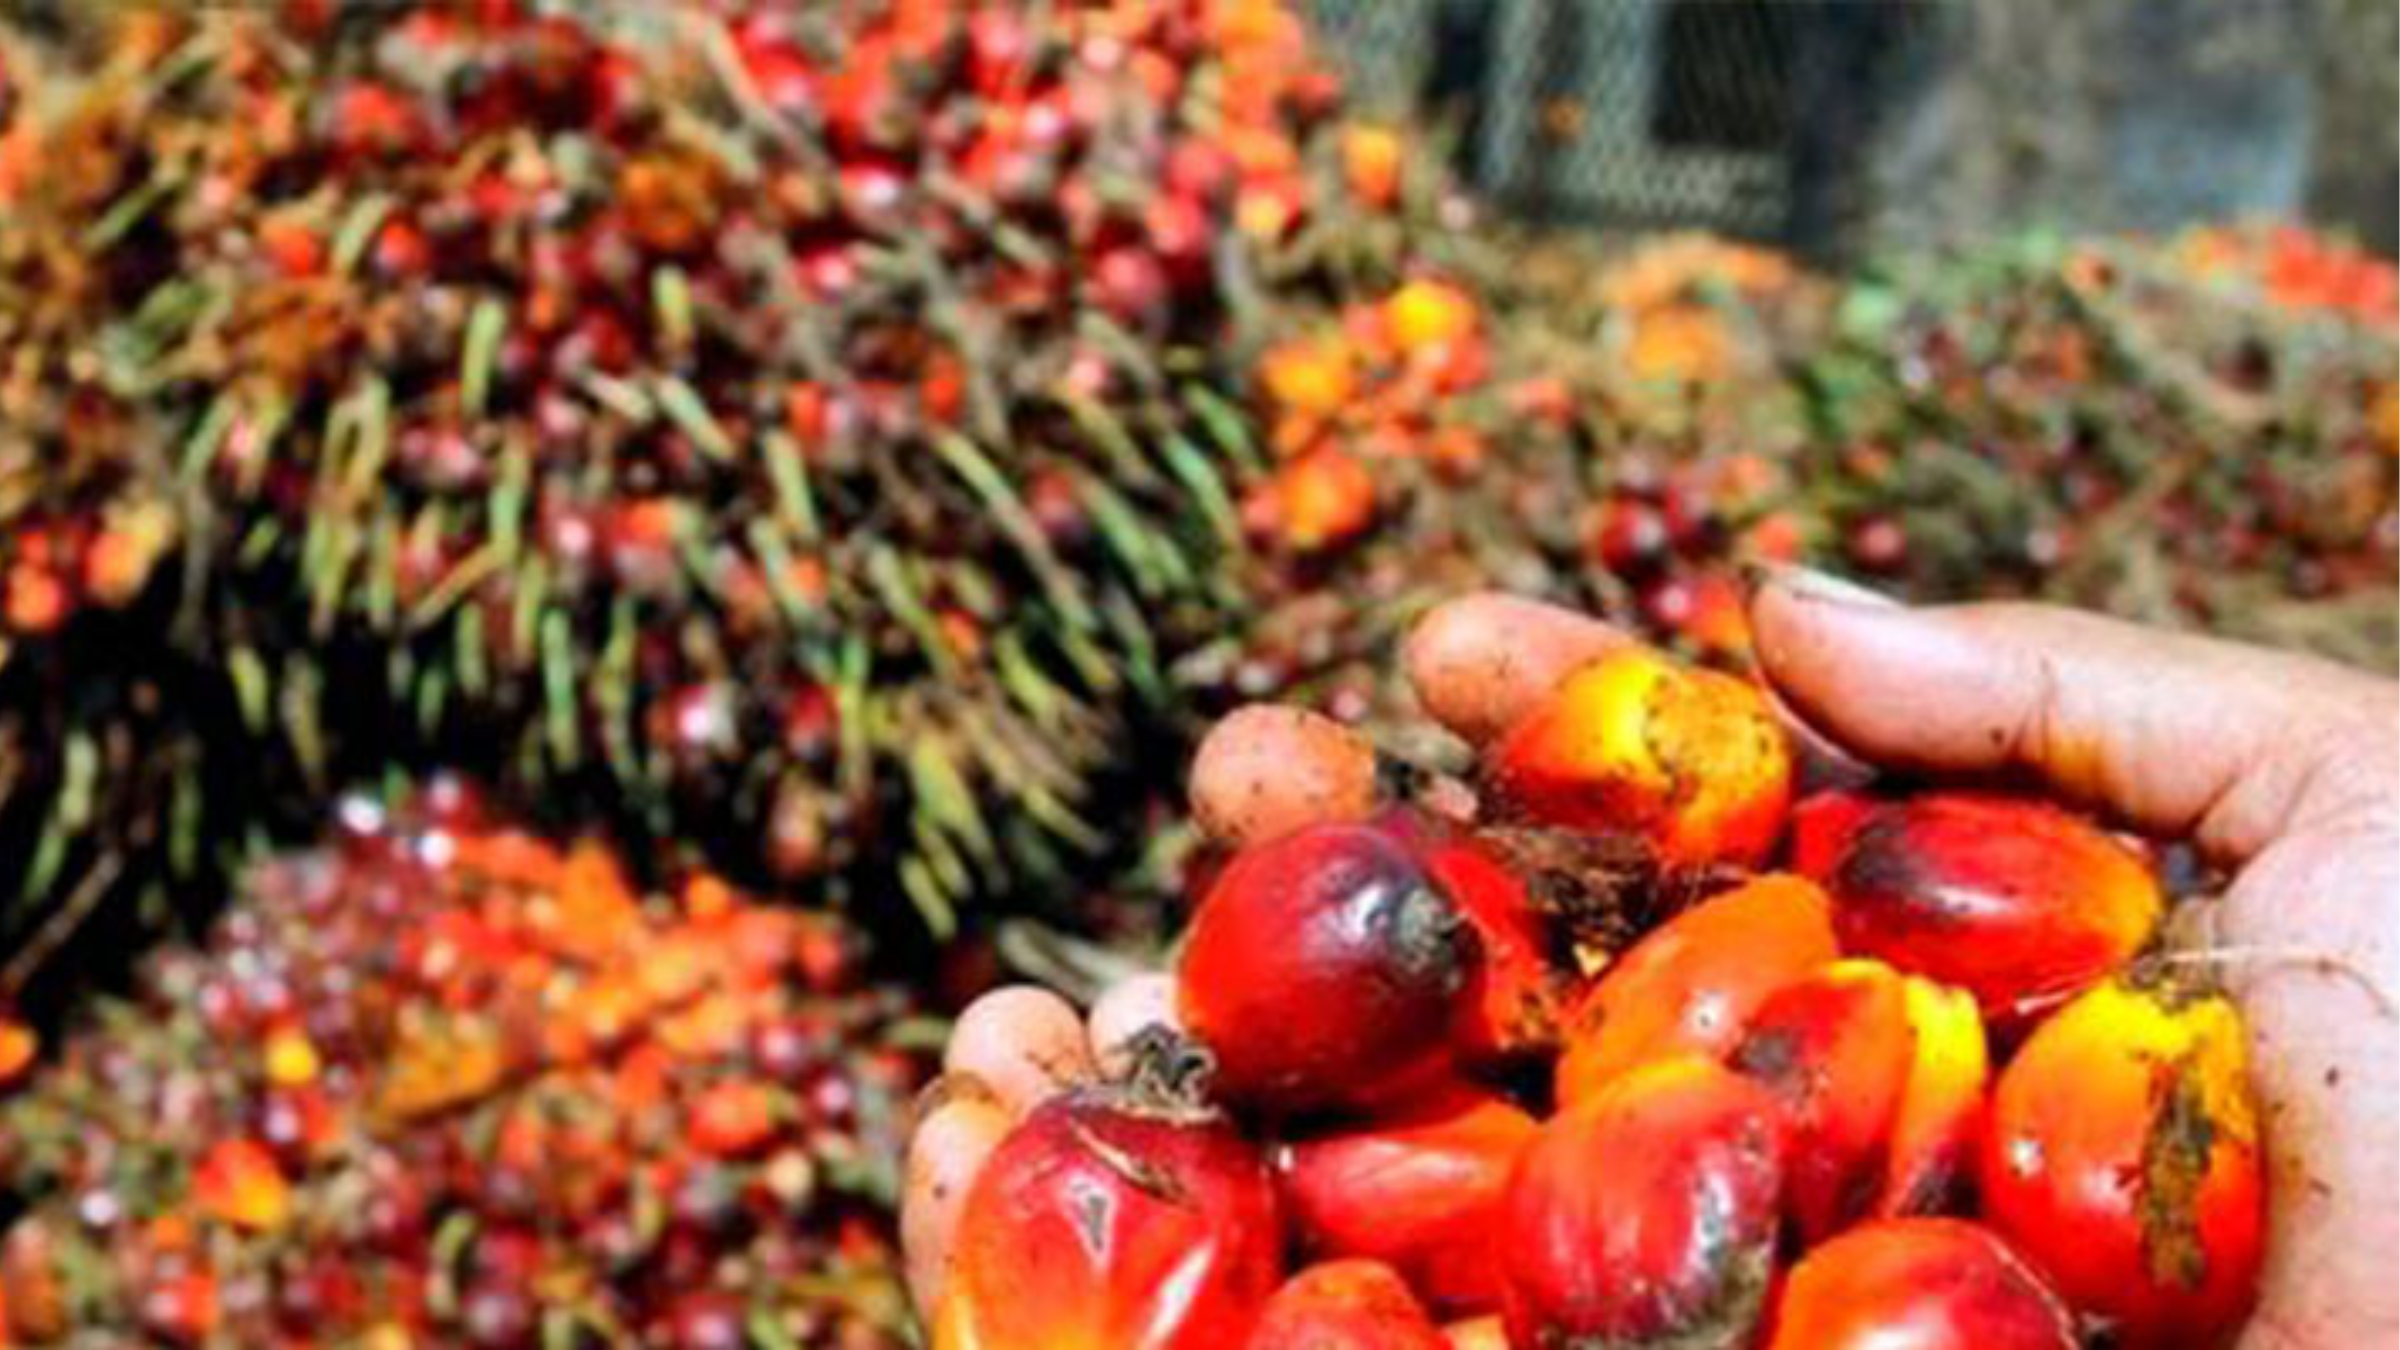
[0,781,924,1350]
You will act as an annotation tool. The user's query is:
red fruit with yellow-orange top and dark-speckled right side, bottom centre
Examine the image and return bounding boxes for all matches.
[1493,1057,1783,1348]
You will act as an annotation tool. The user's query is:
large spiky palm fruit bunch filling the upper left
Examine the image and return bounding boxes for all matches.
[0,0,1622,965]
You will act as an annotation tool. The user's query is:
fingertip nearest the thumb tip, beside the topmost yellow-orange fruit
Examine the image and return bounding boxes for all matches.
[1402,593,1634,745]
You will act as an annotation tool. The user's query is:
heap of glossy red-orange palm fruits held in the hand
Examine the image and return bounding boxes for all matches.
[934,646,2266,1350]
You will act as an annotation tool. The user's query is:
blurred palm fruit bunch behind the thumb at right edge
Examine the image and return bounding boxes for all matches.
[1795,228,2400,668]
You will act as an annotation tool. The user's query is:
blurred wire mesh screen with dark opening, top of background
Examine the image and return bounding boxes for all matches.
[1315,0,1932,235]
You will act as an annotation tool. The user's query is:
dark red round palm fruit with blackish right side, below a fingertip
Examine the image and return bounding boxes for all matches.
[1176,824,1476,1112]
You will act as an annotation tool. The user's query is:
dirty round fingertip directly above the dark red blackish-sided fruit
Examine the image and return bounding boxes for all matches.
[1190,704,1375,846]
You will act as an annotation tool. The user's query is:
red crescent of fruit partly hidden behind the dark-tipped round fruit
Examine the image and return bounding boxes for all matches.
[1375,807,1567,1062]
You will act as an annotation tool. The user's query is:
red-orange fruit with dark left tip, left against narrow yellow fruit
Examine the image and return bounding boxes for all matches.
[1730,958,1913,1242]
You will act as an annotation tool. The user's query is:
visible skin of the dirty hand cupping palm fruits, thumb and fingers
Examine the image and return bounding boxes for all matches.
[902,569,2400,1350]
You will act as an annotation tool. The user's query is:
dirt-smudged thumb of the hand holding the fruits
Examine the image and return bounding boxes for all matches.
[1752,569,2400,860]
